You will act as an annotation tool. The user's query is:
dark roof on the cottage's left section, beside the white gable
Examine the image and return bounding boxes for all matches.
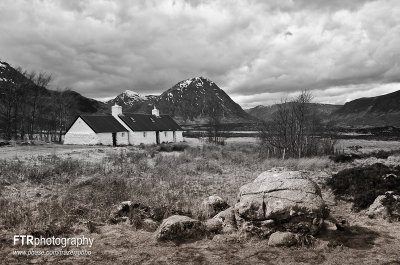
[67,115,128,133]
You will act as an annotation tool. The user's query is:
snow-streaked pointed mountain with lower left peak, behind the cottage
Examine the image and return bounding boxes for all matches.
[107,77,254,124]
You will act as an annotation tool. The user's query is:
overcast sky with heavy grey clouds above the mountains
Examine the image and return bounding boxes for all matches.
[0,0,400,108]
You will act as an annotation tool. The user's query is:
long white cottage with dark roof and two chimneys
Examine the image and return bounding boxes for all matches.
[64,105,183,146]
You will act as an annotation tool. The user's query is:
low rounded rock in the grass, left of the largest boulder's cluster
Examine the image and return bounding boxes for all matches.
[156,215,205,242]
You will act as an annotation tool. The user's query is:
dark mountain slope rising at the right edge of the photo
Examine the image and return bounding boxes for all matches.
[332,90,400,127]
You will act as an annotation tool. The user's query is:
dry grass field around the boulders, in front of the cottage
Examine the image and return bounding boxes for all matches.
[0,139,400,264]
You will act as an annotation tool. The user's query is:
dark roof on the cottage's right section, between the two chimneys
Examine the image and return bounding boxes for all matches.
[119,113,182,131]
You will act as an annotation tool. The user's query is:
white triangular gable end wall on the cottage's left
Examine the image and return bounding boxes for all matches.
[64,117,100,145]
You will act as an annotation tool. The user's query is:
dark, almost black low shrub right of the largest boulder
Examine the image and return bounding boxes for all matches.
[328,163,400,210]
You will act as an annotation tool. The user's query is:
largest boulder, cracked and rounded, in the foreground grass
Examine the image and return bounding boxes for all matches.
[235,169,329,236]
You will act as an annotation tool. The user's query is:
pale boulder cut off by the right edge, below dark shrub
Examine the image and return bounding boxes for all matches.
[367,191,400,220]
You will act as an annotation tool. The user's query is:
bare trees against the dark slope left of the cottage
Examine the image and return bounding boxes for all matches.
[0,68,77,141]
